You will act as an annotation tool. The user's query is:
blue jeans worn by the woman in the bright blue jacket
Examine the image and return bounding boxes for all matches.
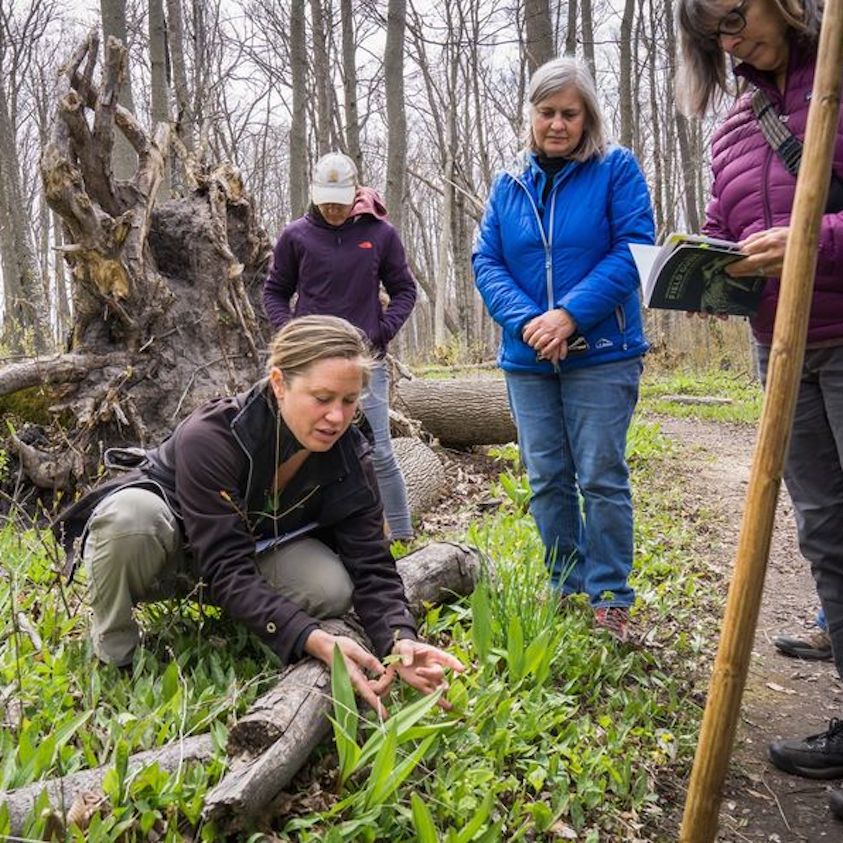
[506,357,642,606]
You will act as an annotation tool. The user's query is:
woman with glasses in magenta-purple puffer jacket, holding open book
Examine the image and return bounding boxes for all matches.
[677,0,843,817]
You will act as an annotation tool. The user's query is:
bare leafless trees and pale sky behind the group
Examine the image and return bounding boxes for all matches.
[0,0,746,372]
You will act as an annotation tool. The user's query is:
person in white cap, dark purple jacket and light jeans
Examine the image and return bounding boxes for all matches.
[263,152,416,539]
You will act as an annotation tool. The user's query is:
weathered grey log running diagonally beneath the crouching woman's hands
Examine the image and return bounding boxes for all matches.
[203,542,480,832]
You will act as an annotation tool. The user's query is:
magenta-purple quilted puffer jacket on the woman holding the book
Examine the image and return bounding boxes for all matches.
[705,40,843,346]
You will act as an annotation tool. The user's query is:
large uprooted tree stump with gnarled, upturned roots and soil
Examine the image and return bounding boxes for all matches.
[0,31,271,488]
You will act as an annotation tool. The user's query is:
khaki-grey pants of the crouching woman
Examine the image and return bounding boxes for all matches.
[82,488,352,665]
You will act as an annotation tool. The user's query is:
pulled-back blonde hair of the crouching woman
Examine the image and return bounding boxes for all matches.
[267,316,372,387]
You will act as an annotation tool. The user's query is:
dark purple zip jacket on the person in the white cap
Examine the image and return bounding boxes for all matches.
[263,201,416,356]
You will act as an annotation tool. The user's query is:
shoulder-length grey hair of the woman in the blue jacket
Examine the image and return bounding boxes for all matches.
[524,56,607,161]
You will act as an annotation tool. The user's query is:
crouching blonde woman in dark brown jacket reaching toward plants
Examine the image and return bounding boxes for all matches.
[55,316,462,712]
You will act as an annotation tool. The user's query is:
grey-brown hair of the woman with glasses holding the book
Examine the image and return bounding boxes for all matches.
[676,0,822,117]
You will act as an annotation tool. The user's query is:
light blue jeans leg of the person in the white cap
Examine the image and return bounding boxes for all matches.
[360,360,413,539]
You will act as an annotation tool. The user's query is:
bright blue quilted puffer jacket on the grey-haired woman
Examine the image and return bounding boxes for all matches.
[472,146,654,373]
